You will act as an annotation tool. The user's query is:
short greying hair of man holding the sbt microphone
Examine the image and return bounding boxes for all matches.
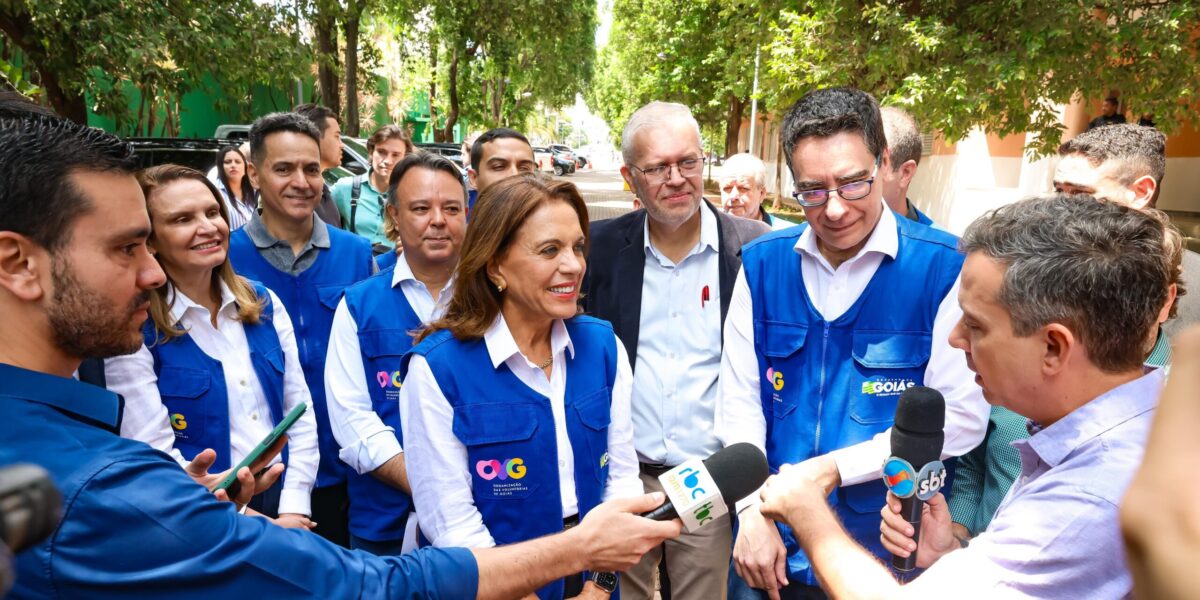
[959,193,1176,372]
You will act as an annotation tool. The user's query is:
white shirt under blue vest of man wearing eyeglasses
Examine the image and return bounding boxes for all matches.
[716,200,989,510]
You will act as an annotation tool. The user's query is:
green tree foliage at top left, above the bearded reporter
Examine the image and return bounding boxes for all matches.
[0,0,308,128]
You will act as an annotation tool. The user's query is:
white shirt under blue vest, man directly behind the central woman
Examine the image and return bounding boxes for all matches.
[325,253,454,475]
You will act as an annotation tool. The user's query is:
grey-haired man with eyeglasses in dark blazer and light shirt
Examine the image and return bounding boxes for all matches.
[583,102,769,600]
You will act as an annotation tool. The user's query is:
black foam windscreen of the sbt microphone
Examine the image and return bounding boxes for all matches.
[892,386,946,469]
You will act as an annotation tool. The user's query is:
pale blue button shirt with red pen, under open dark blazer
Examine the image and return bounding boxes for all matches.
[632,205,721,466]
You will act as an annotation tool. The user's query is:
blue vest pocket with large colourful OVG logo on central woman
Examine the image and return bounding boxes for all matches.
[451,403,542,503]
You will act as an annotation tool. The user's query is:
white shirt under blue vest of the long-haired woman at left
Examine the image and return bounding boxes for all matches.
[104,282,319,515]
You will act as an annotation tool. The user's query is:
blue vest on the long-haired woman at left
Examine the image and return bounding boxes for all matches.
[142,283,288,473]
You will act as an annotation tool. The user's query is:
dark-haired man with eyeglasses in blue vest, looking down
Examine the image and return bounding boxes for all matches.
[716,88,988,599]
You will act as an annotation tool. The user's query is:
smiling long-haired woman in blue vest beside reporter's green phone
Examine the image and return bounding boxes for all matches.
[104,164,318,528]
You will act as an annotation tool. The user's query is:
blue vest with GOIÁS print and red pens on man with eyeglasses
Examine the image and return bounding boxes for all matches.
[742,217,962,586]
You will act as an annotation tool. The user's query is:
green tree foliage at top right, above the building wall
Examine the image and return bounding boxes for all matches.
[764,0,1200,154]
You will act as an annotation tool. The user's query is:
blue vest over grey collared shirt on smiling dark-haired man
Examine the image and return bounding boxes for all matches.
[229,224,373,487]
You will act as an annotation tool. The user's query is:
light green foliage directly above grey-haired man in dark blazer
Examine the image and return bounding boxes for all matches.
[587,0,775,152]
